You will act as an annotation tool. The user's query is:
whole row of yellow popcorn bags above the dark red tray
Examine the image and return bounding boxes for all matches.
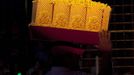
[32,0,111,32]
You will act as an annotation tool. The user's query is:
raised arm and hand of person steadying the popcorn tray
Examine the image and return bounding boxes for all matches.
[98,31,112,75]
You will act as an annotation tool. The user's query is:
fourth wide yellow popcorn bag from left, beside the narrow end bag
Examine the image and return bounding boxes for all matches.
[86,2,103,32]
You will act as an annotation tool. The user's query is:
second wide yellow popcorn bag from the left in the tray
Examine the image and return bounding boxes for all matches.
[52,0,70,28]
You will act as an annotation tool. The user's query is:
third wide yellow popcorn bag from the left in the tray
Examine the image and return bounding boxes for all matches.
[69,3,86,30]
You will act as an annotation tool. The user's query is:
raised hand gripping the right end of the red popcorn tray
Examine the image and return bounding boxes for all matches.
[98,31,112,52]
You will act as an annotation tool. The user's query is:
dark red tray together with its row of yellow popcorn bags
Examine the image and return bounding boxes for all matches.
[29,0,111,45]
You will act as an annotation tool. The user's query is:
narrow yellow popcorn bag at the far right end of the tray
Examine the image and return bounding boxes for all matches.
[102,6,111,31]
